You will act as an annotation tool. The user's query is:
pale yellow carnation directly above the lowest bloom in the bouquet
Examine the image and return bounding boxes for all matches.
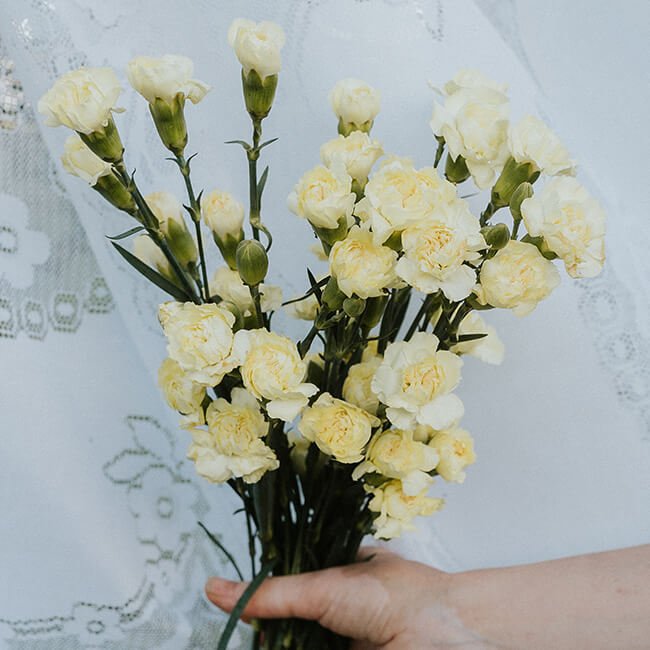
[352,429,439,496]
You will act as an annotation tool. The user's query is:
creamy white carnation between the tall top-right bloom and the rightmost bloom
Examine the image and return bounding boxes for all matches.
[508,115,575,176]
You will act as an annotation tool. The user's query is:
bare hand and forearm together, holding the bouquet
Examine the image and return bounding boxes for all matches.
[206,545,650,650]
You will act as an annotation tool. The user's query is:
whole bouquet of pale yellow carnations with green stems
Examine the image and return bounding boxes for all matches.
[39,19,605,649]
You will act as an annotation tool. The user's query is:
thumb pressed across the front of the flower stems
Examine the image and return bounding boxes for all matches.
[205,570,334,620]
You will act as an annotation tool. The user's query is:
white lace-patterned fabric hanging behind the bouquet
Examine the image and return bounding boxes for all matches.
[0,0,650,650]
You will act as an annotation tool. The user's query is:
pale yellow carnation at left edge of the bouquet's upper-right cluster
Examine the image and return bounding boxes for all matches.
[287,162,356,229]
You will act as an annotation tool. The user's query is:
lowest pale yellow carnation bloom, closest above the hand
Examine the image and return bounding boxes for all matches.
[364,480,444,539]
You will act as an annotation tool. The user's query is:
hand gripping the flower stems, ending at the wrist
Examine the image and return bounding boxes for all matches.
[206,548,489,650]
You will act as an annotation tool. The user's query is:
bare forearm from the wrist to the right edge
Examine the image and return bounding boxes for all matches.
[449,545,650,650]
